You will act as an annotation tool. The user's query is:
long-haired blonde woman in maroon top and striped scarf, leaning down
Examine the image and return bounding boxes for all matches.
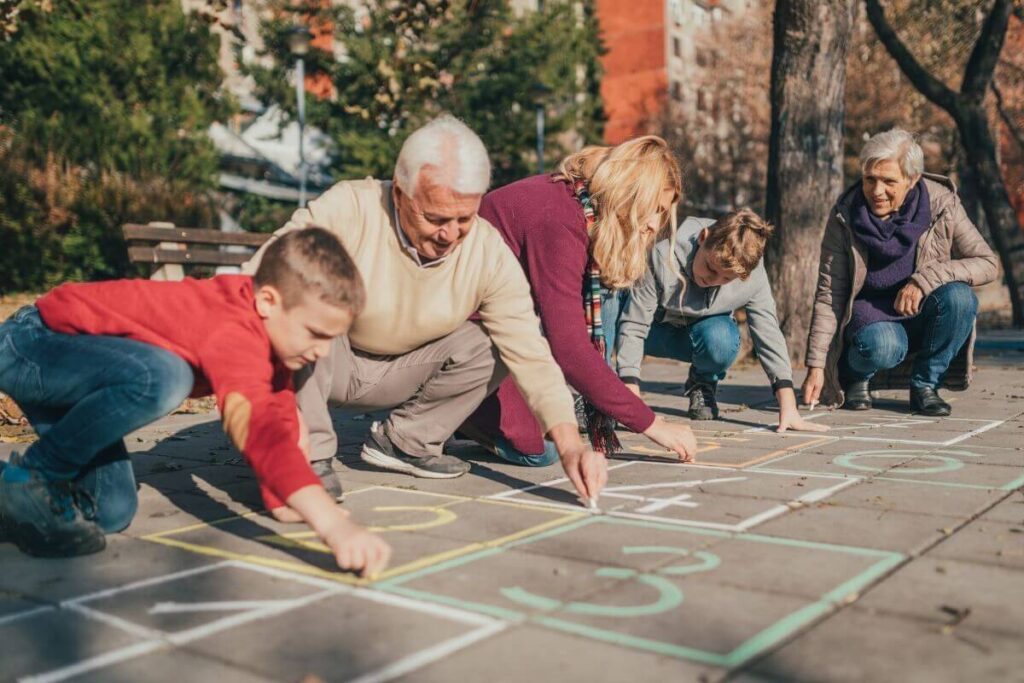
[461,135,696,466]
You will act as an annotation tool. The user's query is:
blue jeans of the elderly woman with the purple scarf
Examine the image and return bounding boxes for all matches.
[842,283,978,389]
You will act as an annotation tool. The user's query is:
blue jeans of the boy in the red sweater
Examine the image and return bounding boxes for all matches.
[0,306,193,532]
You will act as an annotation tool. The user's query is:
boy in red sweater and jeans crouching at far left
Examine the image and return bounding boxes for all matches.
[0,227,390,573]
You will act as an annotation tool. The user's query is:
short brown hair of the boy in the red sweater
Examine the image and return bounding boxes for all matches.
[253,226,367,315]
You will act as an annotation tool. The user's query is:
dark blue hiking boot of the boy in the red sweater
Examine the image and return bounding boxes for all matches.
[0,456,106,557]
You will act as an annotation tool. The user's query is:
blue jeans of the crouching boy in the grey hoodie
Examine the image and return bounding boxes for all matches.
[643,313,739,385]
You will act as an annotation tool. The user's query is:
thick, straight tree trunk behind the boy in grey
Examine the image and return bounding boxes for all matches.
[765,0,857,360]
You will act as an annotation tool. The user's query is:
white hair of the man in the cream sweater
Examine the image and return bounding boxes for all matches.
[394,114,490,197]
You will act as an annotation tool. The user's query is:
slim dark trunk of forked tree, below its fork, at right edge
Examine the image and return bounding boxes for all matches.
[953,105,1024,328]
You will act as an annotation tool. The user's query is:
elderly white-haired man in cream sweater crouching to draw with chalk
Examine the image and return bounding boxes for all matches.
[245,116,607,507]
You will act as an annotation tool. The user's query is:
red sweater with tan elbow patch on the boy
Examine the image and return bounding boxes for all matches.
[36,275,321,507]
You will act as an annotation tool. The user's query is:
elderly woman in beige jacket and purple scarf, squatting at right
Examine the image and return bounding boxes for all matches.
[803,128,996,416]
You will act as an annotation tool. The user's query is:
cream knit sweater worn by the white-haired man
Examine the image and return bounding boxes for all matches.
[243,178,575,432]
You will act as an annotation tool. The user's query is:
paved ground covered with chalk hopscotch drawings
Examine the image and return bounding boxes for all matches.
[0,352,1024,683]
